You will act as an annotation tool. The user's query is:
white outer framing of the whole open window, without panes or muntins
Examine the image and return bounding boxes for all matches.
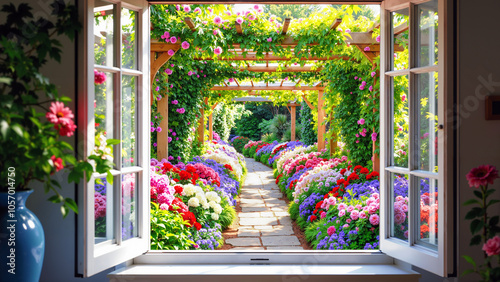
[78,0,453,277]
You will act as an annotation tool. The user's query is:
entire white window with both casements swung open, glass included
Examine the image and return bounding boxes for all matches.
[78,0,453,277]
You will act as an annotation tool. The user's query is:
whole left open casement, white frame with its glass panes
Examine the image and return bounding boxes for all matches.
[78,0,150,277]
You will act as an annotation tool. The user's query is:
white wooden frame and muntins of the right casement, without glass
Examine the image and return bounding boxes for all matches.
[380,0,454,277]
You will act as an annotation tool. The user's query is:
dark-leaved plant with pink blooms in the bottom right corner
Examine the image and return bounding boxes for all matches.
[462,165,500,281]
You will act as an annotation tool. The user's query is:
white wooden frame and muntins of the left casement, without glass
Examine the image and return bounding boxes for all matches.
[77,0,150,277]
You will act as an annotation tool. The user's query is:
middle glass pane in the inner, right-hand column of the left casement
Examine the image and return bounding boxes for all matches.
[121,75,137,167]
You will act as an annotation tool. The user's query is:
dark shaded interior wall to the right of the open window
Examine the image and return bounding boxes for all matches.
[457,0,500,281]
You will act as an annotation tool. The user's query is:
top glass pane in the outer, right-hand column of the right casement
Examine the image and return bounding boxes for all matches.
[415,0,438,67]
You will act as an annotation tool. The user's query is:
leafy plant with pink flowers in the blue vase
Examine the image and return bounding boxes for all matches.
[0,1,117,216]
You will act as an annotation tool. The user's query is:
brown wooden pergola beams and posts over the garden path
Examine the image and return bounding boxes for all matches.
[151,18,408,172]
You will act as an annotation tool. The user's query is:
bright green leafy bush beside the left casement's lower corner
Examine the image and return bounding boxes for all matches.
[150,202,195,250]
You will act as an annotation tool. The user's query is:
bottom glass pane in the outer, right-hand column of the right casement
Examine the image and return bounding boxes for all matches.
[417,177,438,249]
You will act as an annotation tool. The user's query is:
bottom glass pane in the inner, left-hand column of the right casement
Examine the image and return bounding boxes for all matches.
[389,173,409,241]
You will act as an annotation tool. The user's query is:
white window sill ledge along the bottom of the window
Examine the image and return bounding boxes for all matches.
[108,264,420,282]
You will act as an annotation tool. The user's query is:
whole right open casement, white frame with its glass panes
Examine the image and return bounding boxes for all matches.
[380,0,453,276]
